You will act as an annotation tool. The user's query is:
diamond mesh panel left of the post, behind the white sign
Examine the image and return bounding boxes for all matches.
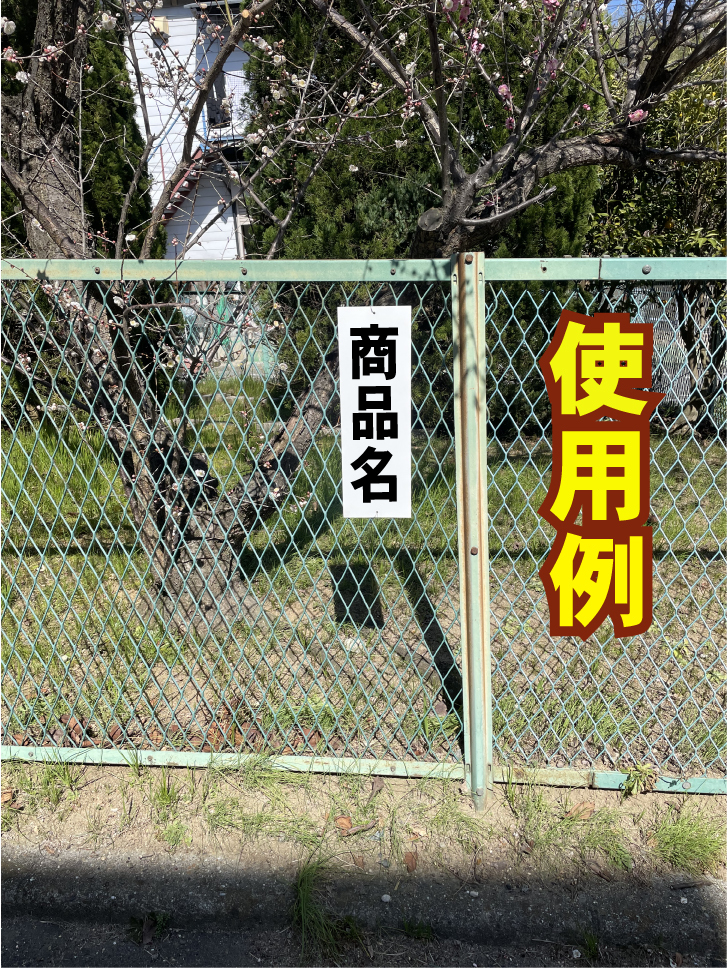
[2,263,462,764]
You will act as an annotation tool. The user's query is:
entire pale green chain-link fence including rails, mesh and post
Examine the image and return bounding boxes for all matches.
[2,255,727,801]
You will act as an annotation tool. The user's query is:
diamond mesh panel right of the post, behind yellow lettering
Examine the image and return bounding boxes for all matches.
[487,274,727,776]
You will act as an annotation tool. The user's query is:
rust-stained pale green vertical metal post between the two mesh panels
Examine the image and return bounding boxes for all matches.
[452,253,492,810]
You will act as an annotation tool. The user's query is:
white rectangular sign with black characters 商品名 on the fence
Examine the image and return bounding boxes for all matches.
[338,306,411,518]
